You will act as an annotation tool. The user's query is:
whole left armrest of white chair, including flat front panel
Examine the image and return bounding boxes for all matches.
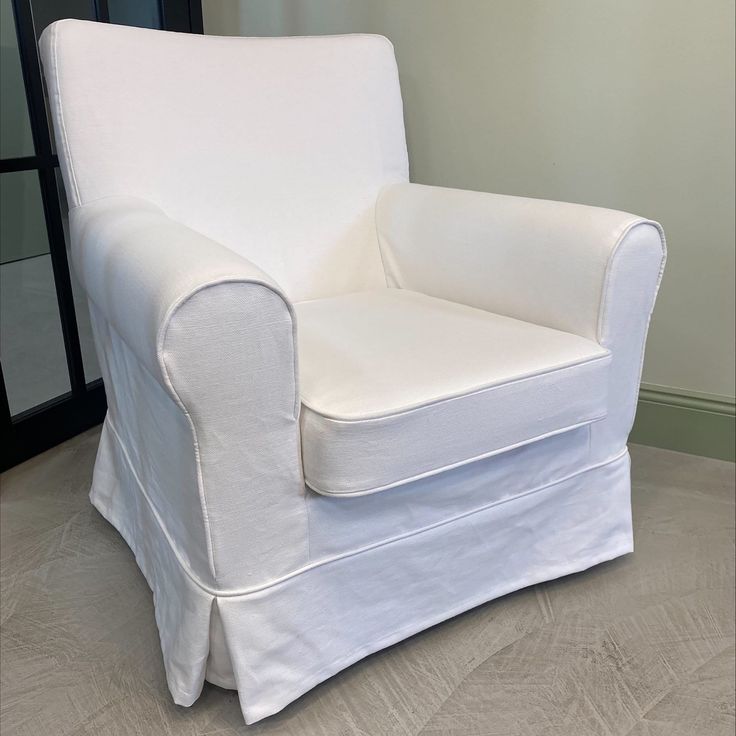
[70,197,308,591]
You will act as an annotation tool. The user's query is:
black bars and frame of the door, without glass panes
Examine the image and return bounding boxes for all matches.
[0,0,203,470]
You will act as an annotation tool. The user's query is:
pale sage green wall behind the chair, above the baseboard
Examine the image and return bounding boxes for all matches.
[203,0,735,400]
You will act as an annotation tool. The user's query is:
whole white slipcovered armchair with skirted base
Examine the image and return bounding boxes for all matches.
[41,21,664,723]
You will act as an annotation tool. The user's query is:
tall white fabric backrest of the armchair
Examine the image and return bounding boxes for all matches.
[41,20,408,300]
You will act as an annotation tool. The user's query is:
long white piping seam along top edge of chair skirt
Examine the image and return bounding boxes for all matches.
[102,422,628,598]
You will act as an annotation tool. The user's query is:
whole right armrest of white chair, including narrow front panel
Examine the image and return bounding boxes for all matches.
[376,183,665,462]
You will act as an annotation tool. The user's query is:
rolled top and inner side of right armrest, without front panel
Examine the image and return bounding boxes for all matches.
[377,184,664,341]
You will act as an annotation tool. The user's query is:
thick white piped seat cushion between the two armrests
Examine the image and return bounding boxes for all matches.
[296,289,611,496]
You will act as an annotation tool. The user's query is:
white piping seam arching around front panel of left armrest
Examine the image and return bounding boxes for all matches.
[156,278,302,581]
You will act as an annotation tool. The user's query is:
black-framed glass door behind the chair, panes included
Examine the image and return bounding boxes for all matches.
[0,0,202,470]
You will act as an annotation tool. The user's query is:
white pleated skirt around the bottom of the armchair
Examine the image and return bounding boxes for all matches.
[90,420,633,723]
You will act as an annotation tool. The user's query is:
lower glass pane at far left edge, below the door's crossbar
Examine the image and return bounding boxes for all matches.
[0,171,70,414]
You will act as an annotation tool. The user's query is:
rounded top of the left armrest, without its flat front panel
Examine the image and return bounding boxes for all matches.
[70,191,293,396]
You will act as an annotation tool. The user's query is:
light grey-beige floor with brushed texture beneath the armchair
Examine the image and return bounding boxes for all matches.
[0,430,734,736]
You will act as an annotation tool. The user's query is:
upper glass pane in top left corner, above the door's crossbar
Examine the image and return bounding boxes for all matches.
[0,0,35,158]
